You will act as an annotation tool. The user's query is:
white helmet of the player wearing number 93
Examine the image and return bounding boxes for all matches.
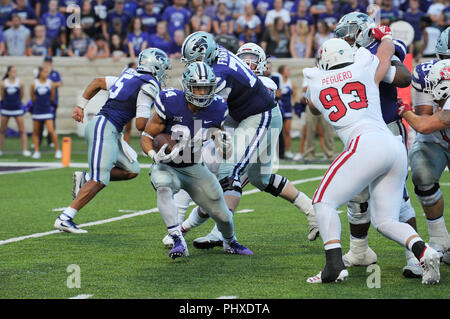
[318,39,354,70]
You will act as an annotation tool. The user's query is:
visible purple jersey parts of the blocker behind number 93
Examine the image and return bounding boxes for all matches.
[366,40,406,123]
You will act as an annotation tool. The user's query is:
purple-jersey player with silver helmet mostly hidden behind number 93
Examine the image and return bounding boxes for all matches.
[335,12,422,278]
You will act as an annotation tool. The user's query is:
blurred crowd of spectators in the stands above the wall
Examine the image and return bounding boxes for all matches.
[0,0,450,59]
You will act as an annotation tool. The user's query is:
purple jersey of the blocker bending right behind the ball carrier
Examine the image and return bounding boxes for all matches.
[212,46,276,122]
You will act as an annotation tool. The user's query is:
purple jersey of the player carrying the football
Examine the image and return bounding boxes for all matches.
[155,89,228,167]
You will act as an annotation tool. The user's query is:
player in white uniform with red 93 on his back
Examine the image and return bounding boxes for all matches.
[303,31,440,284]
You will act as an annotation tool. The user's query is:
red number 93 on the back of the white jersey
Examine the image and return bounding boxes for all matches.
[319,82,367,122]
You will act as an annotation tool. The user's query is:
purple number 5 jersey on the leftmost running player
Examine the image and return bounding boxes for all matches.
[98,68,161,132]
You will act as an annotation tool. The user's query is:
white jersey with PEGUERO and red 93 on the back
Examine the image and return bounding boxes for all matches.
[303,48,392,145]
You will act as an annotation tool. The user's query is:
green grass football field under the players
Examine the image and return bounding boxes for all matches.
[0,136,450,299]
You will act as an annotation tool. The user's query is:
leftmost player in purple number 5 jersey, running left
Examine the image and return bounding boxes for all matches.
[54,48,170,233]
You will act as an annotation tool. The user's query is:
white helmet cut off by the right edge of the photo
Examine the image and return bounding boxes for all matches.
[423,59,450,101]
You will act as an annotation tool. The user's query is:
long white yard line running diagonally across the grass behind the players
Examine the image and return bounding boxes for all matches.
[0,176,322,246]
